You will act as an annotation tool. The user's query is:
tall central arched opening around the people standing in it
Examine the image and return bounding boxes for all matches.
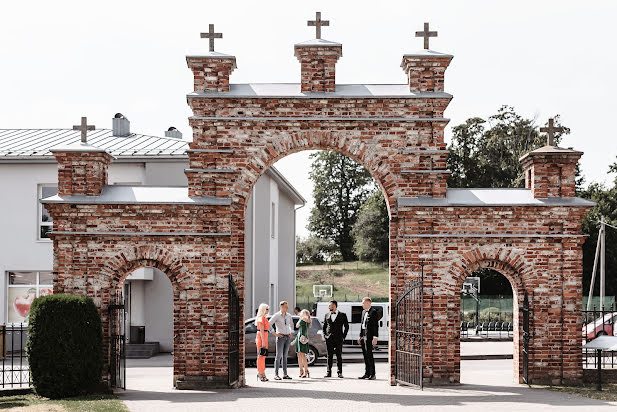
[243,148,390,383]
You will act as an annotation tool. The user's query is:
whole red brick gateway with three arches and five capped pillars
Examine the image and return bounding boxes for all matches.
[43,25,591,389]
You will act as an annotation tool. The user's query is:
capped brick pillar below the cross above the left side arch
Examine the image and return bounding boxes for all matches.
[51,143,114,196]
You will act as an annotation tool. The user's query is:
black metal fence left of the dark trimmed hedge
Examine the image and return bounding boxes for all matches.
[0,323,31,389]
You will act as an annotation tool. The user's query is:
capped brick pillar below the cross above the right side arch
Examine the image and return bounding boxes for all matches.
[520,146,583,199]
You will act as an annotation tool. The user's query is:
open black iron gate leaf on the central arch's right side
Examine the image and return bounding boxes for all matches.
[394,268,424,389]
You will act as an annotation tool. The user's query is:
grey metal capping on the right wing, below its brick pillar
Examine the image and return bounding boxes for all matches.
[398,189,595,207]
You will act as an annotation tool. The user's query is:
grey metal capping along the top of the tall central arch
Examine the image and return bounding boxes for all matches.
[187,83,452,99]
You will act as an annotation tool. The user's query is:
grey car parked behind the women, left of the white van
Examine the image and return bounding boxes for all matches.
[244,316,328,365]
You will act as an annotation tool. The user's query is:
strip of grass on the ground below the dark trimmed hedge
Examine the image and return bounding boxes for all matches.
[0,394,128,412]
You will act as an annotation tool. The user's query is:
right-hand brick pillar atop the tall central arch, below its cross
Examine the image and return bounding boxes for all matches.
[401,50,453,92]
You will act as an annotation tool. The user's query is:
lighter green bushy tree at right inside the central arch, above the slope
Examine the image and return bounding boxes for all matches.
[352,189,389,262]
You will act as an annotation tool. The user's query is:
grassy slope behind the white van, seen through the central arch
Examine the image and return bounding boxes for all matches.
[296,262,390,303]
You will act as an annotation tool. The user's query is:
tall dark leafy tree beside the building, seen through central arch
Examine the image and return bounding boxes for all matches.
[308,151,375,261]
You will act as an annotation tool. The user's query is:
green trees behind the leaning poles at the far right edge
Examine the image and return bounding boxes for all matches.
[579,162,617,295]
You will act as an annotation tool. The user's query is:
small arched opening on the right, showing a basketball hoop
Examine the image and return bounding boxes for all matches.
[457,261,524,385]
